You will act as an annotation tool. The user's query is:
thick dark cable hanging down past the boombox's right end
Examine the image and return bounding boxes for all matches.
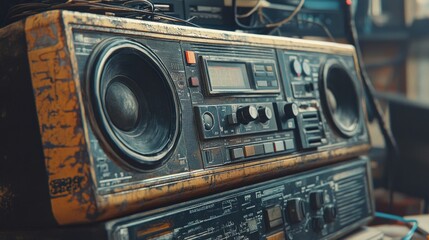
[344,0,399,210]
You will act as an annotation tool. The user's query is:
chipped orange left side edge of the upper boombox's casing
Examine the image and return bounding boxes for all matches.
[25,12,94,224]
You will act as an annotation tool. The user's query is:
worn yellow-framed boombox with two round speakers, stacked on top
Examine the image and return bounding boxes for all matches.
[0,11,370,226]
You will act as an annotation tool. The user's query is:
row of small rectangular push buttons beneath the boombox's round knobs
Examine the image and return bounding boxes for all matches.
[229,139,295,159]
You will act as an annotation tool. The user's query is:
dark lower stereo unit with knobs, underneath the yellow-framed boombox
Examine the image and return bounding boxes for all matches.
[0,157,375,240]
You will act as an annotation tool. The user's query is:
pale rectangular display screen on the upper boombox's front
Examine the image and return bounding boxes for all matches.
[207,61,250,91]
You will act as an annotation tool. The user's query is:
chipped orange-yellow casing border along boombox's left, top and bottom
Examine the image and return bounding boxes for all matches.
[20,11,370,224]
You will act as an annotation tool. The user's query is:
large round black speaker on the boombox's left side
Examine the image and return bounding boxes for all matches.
[86,38,180,169]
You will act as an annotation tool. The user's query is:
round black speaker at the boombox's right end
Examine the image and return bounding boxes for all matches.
[319,59,361,137]
